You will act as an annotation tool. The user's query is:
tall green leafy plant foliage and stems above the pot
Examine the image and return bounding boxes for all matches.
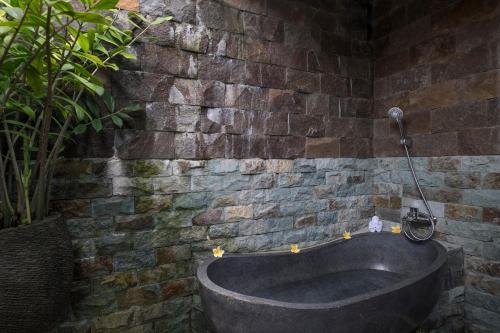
[0,0,170,228]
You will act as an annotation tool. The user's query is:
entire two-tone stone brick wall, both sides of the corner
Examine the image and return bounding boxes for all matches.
[49,0,500,333]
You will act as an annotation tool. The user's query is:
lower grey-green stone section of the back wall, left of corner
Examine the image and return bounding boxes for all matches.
[53,158,374,333]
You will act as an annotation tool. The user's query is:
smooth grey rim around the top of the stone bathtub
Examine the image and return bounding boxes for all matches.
[196,231,447,310]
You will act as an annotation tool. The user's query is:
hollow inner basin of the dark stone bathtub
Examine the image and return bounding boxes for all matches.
[207,233,439,303]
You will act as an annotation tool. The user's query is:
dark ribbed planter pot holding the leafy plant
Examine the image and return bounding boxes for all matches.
[0,216,73,333]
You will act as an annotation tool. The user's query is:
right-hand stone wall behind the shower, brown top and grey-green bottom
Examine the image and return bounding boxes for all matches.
[372,0,500,332]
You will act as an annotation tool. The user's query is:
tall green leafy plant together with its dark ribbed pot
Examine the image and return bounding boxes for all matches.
[0,0,170,332]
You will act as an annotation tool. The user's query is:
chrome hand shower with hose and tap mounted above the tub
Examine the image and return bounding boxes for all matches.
[387,107,437,242]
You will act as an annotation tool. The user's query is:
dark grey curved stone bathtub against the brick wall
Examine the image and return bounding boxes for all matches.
[197,232,446,333]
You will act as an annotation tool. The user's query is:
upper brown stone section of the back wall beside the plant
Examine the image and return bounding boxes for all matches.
[77,0,372,159]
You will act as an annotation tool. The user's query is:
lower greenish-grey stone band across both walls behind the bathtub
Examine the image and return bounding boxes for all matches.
[53,155,500,333]
